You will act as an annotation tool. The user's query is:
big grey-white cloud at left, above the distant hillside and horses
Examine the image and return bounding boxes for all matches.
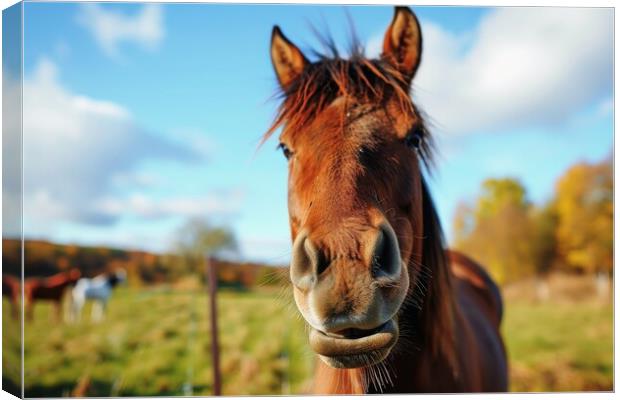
[23,60,198,233]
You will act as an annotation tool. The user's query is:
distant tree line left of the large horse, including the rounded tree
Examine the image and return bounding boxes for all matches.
[2,219,285,289]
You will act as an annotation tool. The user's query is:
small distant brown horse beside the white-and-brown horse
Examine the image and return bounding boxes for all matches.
[24,268,81,320]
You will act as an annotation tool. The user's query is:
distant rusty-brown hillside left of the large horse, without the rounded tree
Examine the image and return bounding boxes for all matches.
[2,239,285,288]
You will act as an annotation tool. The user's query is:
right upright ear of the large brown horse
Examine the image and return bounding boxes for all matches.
[381,7,422,83]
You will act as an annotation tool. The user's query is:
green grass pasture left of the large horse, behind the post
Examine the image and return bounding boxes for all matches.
[3,288,313,397]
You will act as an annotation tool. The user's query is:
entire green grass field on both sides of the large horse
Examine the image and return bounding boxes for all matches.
[3,278,613,397]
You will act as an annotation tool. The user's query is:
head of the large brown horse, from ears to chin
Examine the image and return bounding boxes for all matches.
[267,7,438,368]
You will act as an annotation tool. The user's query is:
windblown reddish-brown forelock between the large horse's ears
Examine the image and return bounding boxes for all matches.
[261,42,435,171]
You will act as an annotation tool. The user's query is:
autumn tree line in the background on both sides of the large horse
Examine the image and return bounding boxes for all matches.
[2,156,613,288]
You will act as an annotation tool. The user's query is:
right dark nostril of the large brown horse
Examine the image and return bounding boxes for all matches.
[371,223,401,278]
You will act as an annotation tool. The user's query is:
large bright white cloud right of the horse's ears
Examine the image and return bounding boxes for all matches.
[369,7,613,134]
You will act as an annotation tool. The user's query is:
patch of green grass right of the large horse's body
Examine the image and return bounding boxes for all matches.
[503,301,613,392]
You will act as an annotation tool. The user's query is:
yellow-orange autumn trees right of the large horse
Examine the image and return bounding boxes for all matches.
[452,156,613,283]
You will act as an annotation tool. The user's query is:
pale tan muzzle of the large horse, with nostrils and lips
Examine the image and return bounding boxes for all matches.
[291,221,409,368]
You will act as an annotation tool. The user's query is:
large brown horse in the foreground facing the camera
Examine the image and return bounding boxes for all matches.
[265,7,508,393]
